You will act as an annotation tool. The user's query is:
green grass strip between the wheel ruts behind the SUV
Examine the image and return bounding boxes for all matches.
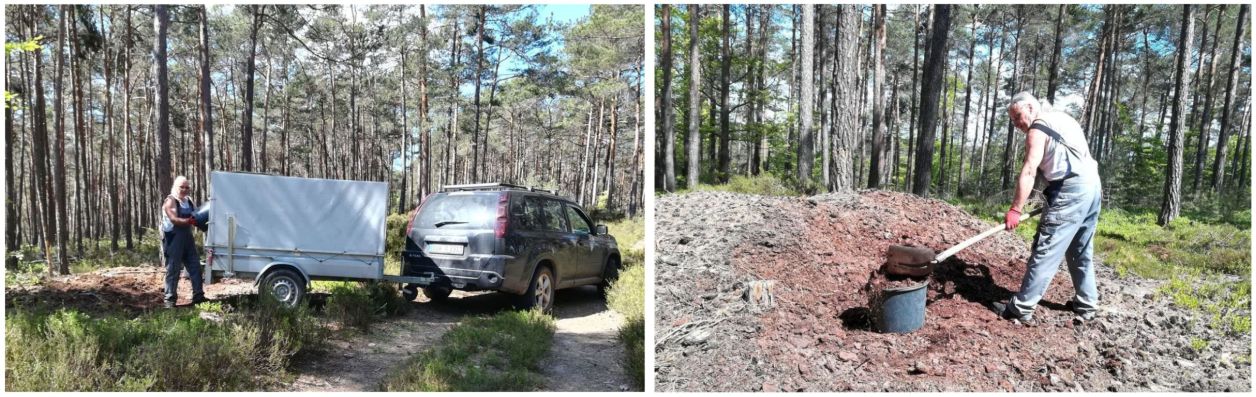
[381,310,554,392]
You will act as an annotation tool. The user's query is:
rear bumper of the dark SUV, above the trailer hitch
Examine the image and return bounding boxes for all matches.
[402,253,524,294]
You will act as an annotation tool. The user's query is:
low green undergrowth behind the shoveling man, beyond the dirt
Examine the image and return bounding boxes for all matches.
[953,197,1251,334]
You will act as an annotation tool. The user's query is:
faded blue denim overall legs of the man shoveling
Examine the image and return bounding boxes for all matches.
[1009,176,1103,319]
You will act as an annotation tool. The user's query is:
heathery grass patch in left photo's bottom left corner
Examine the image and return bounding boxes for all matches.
[5,295,325,391]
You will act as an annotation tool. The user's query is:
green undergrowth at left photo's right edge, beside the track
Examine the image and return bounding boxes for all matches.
[607,217,646,391]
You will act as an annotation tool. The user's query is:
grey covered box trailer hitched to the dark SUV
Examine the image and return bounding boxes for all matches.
[205,171,432,305]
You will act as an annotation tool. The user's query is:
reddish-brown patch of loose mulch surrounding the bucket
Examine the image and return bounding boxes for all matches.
[732,191,1076,389]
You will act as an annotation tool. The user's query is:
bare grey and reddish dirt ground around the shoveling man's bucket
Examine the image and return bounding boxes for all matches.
[654,191,1251,392]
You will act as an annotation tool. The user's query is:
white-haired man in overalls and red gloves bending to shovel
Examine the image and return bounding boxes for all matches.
[993,92,1102,325]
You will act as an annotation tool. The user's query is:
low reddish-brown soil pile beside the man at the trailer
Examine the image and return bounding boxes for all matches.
[5,266,254,312]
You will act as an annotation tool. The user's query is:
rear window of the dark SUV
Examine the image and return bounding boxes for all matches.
[414,192,497,229]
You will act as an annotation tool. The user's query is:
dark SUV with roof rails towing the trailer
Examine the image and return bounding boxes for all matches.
[402,183,620,310]
